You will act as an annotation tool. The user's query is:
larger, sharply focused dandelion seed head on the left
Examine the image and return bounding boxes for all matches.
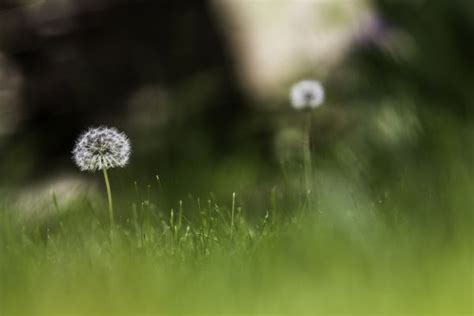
[72,126,131,172]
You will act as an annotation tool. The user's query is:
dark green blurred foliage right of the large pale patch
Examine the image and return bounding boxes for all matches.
[320,0,474,205]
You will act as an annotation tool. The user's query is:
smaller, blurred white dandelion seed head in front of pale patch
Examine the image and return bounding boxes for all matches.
[290,80,324,110]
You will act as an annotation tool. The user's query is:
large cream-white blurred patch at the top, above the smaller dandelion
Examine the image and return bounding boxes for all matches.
[213,0,371,98]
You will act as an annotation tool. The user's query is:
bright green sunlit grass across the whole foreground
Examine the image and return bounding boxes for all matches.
[0,178,472,315]
